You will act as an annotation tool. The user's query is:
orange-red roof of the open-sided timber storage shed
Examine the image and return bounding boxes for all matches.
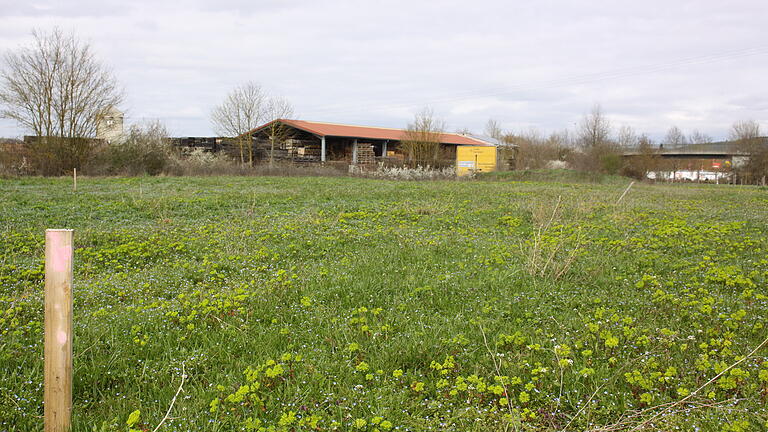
[250,119,493,146]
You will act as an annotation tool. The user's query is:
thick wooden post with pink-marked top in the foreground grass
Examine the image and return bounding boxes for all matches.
[43,229,73,432]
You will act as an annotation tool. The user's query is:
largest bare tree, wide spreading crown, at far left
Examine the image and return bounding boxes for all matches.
[0,28,123,174]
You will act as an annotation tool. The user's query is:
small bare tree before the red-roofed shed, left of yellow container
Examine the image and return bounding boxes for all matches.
[401,108,445,164]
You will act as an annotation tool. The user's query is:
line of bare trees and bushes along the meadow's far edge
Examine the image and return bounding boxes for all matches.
[0,29,768,182]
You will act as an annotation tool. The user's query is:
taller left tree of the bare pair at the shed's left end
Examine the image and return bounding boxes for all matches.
[211,82,267,165]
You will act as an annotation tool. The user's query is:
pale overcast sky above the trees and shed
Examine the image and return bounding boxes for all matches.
[0,0,768,139]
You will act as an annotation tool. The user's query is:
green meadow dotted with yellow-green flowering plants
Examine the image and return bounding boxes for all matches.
[0,178,768,432]
